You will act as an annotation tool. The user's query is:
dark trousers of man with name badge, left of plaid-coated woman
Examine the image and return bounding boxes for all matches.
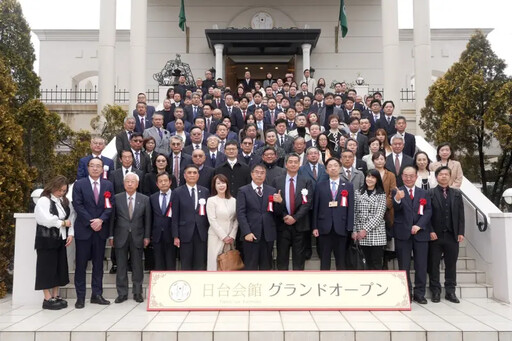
[318,228,347,270]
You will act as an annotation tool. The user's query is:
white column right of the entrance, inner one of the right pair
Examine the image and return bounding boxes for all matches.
[382,0,400,111]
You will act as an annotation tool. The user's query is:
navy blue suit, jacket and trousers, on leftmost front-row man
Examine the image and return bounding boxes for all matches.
[73,177,115,299]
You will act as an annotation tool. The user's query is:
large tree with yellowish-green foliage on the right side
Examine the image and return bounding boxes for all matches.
[420,31,512,204]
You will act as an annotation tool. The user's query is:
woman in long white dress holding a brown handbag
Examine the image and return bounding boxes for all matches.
[206,174,238,271]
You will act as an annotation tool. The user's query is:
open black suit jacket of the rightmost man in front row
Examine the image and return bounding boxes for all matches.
[428,186,465,240]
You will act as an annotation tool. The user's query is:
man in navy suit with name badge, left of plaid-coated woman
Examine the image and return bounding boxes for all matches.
[312,158,354,270]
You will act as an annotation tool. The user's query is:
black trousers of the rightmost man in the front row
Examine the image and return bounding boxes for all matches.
[428,231,459,294]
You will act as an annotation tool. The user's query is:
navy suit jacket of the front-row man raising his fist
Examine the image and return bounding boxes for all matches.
[392,186,432,242]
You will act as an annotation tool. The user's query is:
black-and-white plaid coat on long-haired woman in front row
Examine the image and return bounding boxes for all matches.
[354,190,387,246]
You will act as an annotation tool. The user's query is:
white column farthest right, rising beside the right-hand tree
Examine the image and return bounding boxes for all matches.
[413,0,432,135]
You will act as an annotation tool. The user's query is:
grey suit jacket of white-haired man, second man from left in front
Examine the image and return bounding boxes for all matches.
[110,192,151,249]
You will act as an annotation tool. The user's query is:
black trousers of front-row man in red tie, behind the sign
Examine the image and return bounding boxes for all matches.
[277,225,304,270]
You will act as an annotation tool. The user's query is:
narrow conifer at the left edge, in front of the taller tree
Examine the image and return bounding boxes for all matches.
[0,58,34,297]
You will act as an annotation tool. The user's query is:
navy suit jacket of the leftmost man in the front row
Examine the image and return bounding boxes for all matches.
[73,177,115,240]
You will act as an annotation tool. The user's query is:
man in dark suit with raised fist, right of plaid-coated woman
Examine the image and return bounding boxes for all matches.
[393,166,432,304]
